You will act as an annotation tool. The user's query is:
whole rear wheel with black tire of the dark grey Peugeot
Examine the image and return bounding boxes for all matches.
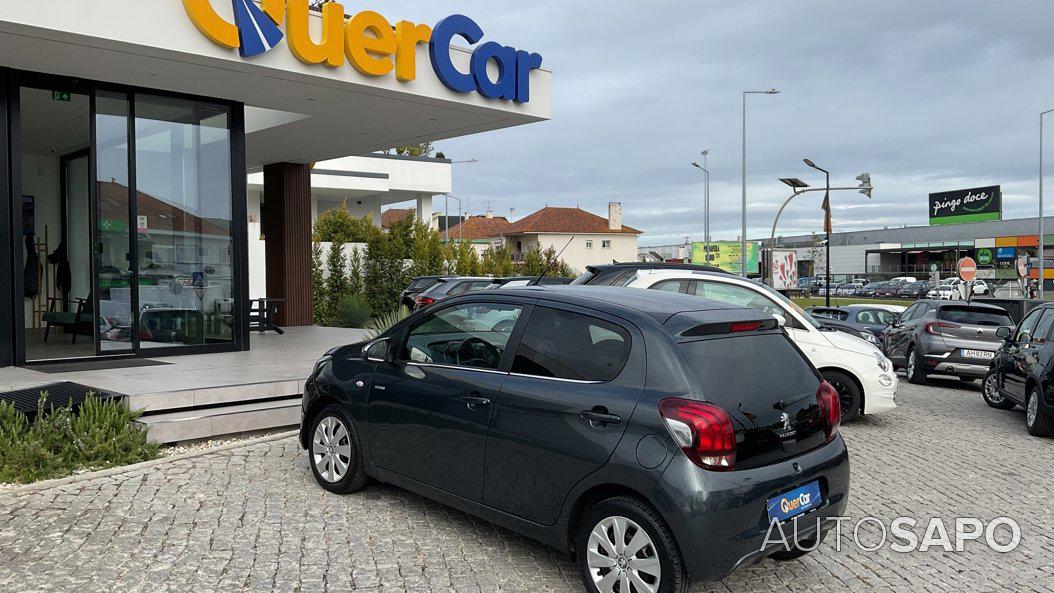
[575,496,688,593]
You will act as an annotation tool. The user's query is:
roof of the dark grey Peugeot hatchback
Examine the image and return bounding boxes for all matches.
[482,284,767,323]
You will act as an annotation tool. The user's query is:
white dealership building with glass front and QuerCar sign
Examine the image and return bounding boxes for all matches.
[0,0,550,365]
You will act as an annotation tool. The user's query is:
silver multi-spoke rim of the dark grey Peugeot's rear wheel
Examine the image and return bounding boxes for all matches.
[586,516,662,593]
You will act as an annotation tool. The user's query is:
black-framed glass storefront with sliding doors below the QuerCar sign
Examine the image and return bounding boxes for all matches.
[0,71,248,363]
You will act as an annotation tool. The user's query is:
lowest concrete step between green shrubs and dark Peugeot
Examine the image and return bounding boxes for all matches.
[139,396,300,443]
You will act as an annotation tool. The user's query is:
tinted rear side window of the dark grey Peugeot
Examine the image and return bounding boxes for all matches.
[512,307,630,381]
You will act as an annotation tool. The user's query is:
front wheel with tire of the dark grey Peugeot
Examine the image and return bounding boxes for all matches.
[308,404,366,494]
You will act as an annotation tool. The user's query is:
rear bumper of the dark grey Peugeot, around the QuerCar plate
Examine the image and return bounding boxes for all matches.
[652,436,850,581]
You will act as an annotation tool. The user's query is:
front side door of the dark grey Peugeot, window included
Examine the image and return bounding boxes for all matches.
[367,301,524,501]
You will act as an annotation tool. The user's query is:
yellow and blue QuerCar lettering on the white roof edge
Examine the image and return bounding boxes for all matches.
[183,0,542,103]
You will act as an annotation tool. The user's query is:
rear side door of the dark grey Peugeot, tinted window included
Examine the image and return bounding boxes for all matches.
[483,301,645,525]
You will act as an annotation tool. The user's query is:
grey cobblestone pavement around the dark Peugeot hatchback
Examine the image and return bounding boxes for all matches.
[0,381,1054,593]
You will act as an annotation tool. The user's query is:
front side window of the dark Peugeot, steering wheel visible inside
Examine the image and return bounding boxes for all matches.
[399,302,523,369]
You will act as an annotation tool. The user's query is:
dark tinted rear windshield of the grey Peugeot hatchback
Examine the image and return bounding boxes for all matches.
[681,333,820,408]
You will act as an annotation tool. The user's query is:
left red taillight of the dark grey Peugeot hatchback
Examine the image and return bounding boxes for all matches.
[659,397,736,471]
